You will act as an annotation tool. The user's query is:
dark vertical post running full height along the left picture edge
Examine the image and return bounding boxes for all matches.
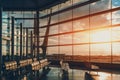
[0,0,2,77]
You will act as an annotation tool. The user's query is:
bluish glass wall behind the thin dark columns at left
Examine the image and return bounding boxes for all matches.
[2,11,35,60]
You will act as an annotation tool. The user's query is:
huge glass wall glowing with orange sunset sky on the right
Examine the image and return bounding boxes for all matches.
[40,0,120,67]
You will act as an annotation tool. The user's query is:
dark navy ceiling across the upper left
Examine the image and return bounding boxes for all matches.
[2,0,68,11]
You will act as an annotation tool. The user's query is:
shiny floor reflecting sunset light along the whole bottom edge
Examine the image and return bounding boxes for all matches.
[2,67,120,80]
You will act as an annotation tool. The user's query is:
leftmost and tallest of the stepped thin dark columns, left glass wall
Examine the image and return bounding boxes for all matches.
[11,17,14,60]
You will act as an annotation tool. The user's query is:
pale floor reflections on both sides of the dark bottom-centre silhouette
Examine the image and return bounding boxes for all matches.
[47,68,85,80]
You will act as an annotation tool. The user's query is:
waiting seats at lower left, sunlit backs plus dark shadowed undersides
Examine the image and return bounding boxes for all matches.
[3,59,50,77]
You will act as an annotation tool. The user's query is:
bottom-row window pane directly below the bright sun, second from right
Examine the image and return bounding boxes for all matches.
[90,43,111,63]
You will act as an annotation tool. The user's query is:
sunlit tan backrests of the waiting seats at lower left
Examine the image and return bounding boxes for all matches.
[4,59,49,71]
